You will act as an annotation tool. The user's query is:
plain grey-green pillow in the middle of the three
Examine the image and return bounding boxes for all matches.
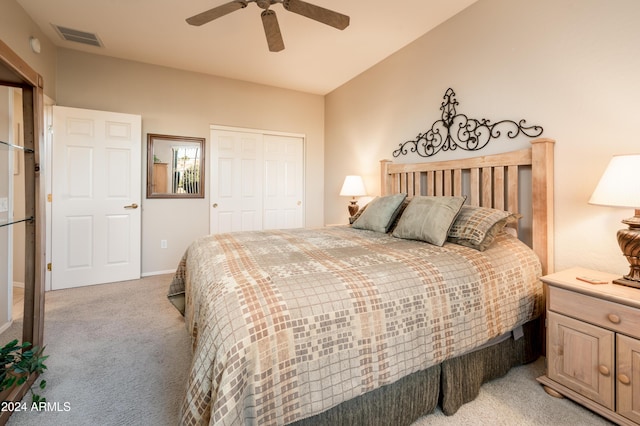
[392,196,467,246]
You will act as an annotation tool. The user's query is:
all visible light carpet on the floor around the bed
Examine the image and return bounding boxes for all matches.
[0,275,609,426]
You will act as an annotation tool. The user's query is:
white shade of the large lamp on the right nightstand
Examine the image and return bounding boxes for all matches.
[589,154,640,209]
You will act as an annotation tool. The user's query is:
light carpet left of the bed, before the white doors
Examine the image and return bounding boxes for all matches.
[7,275,191,425]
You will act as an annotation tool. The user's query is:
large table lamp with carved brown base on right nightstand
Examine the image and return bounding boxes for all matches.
[589,154,640,288]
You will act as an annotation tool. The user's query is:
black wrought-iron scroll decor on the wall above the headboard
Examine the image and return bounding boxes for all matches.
[393,88,543,157]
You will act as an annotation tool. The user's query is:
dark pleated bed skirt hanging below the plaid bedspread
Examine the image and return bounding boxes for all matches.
[294,318,543,426]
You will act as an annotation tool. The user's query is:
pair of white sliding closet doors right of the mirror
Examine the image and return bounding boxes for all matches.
[210,128,304,234]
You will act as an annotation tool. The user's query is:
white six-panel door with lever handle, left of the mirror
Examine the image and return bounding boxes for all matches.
[51,106,142,290]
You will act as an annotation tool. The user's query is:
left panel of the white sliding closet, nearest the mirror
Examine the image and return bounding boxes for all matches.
[209,130,263,234]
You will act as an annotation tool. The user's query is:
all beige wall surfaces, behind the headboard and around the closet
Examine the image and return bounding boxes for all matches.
[5,0,640,273]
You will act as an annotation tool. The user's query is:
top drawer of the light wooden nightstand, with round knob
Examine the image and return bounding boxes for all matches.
[549,287,640,338]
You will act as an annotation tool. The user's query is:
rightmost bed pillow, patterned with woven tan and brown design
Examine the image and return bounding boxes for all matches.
[448,205,522,251]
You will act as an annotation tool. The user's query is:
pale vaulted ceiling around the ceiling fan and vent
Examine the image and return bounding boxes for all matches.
[17,0,477,94]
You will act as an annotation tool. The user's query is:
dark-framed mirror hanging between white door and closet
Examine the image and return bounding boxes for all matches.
[147,133,205,198]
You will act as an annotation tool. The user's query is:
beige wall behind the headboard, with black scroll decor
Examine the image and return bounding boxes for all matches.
[325,0,640,273]
